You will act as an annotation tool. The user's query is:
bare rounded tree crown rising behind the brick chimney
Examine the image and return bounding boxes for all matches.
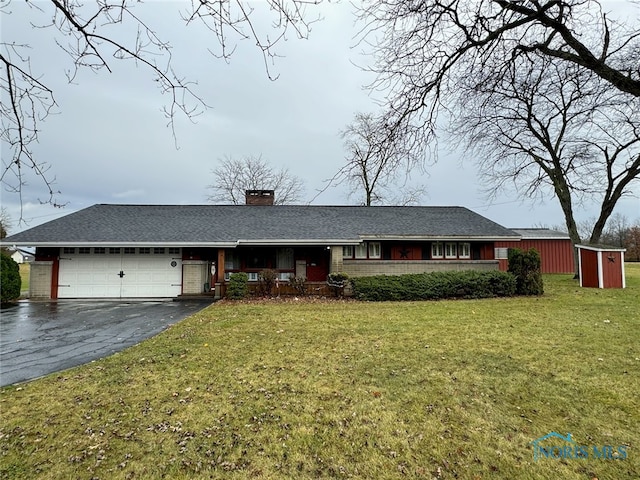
[207,155,304,205]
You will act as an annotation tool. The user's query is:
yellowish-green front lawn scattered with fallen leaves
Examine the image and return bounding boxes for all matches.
[0,264,640,480]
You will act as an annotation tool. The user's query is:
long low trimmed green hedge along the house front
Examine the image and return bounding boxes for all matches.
[351,270,516,302]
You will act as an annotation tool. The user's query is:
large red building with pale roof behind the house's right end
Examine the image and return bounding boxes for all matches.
[495,228,576,273]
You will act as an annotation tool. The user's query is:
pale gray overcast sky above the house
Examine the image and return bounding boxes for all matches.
[0,2,640,233]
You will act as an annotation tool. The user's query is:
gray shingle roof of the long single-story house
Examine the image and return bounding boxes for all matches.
[3,204,519,246]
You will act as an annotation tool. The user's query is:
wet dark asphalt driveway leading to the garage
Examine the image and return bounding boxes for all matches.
[0,300,211,386]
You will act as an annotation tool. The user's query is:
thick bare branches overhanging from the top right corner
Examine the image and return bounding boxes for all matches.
[358,0,640,141]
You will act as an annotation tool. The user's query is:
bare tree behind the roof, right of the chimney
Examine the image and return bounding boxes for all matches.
[325,113,425,206]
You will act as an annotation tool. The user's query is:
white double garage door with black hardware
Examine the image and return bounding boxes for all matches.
[58,247,182,298]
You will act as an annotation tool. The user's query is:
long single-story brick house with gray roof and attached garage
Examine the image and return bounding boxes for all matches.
[2,191,520,299]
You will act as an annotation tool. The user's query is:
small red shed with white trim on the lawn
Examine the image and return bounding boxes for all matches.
[576,245,626,288]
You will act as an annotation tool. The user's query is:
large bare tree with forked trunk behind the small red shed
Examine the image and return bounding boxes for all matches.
[452,48,640,256]
